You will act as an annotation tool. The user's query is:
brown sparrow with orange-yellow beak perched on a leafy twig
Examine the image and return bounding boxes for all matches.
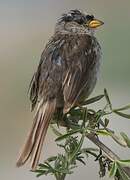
[16,9,104,171]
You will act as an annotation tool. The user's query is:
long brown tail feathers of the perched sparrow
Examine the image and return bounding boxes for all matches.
[16,99,56,170]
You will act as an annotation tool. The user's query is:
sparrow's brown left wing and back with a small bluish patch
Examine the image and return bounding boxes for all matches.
[29,36,64,110]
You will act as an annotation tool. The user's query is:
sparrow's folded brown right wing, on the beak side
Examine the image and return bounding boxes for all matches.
[63,35,100,113]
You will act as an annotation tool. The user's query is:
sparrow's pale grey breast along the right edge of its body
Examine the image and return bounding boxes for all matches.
[79,39,101,101]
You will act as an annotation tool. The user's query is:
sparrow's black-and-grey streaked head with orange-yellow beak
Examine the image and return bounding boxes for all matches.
[56,9,104,34]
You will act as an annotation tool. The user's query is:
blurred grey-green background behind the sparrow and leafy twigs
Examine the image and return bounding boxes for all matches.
[0,0,130,180]
